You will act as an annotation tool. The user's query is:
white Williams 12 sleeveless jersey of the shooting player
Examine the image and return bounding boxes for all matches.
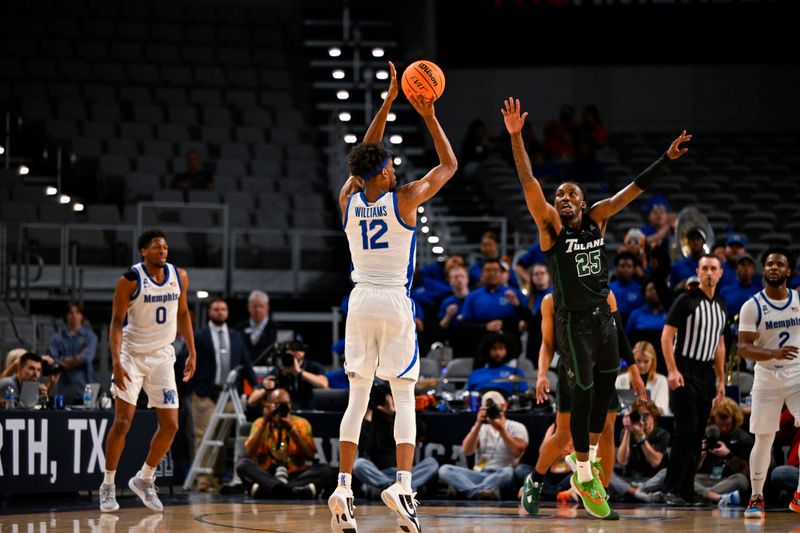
[344,192,417,290]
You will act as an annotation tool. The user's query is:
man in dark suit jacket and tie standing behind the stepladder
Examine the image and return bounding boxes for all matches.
[191,298,257,492]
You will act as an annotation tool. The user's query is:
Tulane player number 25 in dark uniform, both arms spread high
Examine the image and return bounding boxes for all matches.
[500,98,692,520]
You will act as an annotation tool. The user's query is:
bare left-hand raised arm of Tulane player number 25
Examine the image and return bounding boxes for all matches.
[500,98,561,250]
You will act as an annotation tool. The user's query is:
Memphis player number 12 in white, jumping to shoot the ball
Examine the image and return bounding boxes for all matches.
[328,63,457,533]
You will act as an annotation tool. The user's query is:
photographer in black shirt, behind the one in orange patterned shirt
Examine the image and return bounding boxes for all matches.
[247,340,328,409]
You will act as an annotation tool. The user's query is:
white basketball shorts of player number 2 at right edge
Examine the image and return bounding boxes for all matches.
[750,364,800,434]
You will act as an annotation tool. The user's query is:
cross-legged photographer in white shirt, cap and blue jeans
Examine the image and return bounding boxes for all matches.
[439,391,528,500]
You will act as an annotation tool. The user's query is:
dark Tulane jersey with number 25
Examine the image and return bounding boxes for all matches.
[544,213,609,312]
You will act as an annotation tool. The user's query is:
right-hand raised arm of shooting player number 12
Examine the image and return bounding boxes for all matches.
[397,95,458,222]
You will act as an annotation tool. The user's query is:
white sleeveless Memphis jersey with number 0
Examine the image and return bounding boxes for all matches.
[122,263,181,354]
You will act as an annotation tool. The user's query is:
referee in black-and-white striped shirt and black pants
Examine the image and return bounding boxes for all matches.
[661,255,727,506]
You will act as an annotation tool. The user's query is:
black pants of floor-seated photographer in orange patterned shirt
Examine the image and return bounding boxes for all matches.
[236,459,338,500]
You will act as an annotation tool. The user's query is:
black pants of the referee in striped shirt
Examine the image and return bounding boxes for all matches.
[664,357,716,500]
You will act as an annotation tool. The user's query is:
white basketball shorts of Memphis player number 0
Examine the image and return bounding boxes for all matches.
[111,344,178,409]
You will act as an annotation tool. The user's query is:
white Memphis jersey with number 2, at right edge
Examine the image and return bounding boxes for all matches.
[739,289,800,368]
